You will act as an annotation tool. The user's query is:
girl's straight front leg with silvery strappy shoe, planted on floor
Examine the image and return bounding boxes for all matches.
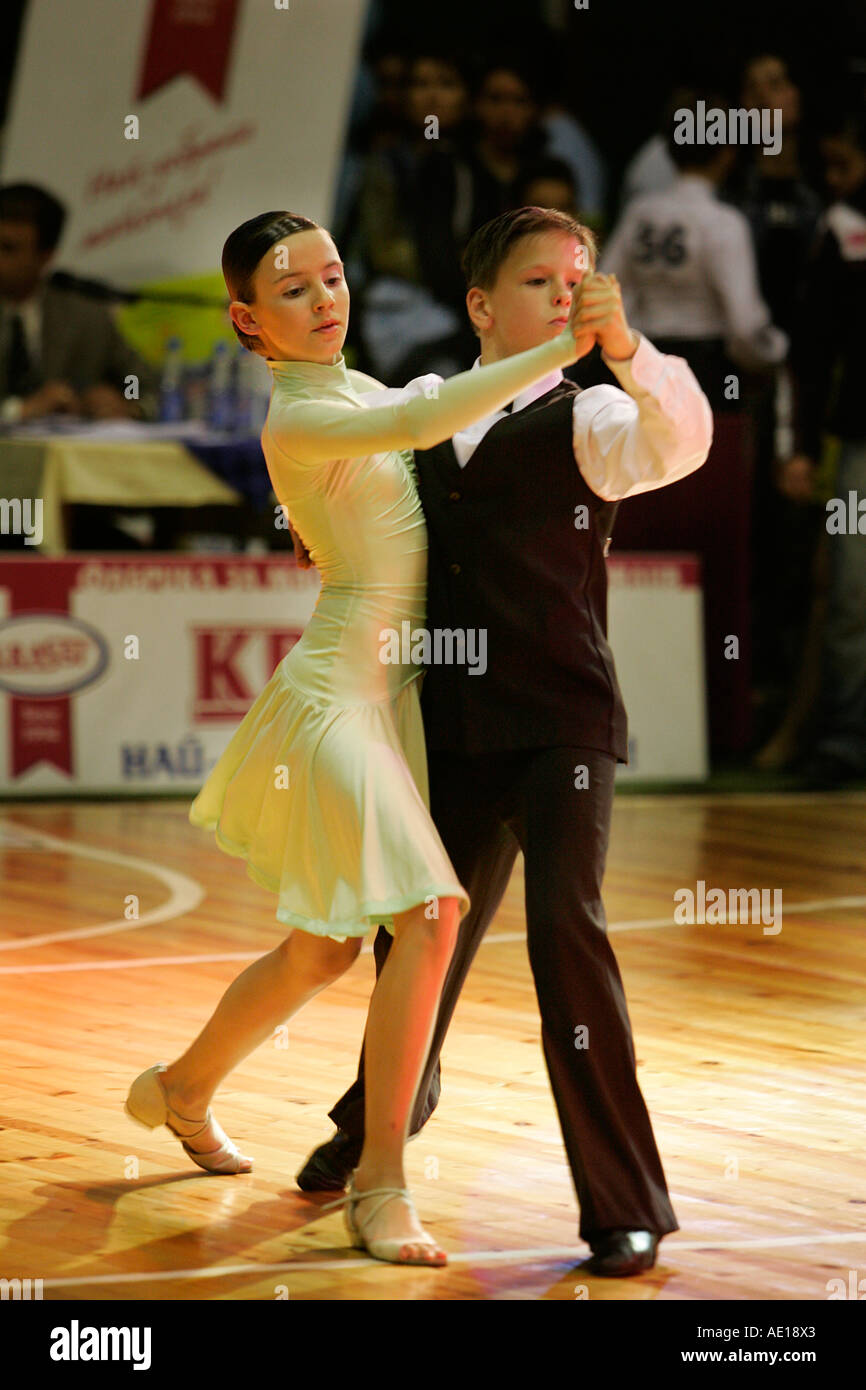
[354,898,459,1262]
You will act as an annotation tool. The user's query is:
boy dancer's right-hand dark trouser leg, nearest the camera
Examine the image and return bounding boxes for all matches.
[512,748,678,1240]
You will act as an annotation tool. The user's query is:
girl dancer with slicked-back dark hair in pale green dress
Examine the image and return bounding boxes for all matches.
[126,213,594,1265]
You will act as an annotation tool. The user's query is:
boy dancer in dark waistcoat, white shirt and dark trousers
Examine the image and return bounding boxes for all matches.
[291,207,712,1276]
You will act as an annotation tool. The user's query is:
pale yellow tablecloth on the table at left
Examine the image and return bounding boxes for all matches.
[0,435,243,555]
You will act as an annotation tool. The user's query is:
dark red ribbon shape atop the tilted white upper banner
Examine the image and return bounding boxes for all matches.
[135,0,238,101]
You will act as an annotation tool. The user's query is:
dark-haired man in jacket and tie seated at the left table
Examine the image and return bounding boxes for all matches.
[0,183,156,424]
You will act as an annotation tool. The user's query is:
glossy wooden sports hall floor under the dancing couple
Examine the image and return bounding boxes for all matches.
[0,792,866,1301]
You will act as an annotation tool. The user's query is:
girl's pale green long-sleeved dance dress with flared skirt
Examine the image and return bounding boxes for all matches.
[189,334,583,940]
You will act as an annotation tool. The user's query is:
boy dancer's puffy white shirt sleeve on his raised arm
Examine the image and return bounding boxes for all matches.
[573,334,713,502]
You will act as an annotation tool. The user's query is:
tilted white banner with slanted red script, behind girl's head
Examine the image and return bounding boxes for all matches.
[1,0,367,284]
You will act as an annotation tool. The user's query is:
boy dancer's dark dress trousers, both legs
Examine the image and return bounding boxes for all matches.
[331,748,678,1241]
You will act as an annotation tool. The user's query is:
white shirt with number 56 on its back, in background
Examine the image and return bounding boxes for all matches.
[599,174,788,370]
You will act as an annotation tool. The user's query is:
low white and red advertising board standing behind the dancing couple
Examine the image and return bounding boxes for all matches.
[0,555,706,796]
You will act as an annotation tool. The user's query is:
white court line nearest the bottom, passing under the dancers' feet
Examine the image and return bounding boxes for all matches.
[29,1230,866,1289]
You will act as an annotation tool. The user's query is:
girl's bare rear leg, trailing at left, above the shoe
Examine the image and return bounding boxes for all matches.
[163,931,361,1131]
